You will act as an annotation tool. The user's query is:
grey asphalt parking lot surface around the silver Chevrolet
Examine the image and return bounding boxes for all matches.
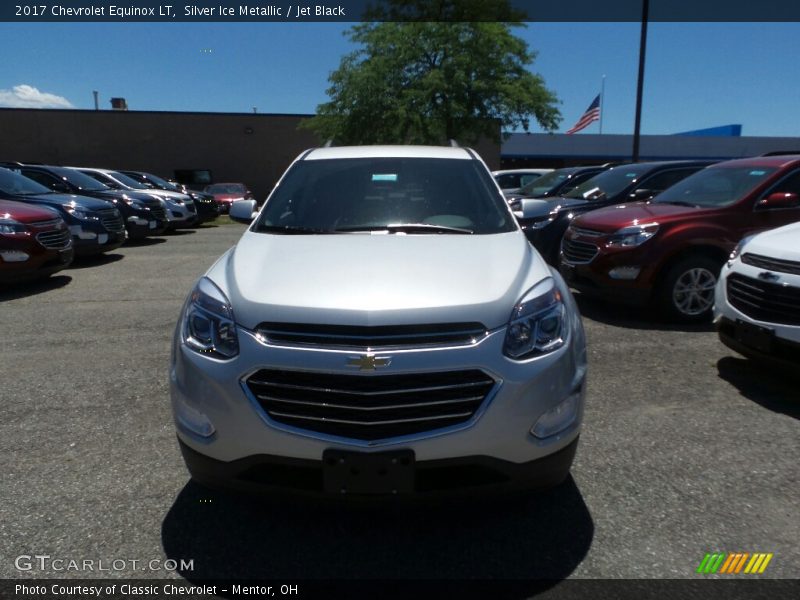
[0,225,800,580]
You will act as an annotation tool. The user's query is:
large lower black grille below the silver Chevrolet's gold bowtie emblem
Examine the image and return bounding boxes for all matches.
[246,369,495,441]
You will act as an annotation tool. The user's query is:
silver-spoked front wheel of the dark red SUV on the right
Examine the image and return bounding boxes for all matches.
[657,256,722,323]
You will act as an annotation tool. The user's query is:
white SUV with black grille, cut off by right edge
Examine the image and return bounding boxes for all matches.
[714,223,800,371]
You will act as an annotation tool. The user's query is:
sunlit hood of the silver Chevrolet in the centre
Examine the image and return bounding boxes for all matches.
[208,231,550,329]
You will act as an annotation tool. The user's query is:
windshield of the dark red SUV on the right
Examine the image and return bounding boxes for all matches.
[653,167,776,208]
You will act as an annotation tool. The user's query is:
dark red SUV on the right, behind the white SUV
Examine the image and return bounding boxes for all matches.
[560,155,800,321]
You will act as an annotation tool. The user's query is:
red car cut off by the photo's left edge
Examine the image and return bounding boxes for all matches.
[0,200,74,283]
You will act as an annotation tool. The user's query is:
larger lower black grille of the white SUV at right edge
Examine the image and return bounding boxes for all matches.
[727,273,800,325]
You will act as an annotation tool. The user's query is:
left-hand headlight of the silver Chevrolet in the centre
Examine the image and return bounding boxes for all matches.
[182,277,239,358]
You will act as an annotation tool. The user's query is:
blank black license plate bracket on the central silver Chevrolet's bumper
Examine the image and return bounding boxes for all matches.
[322,449,415,495]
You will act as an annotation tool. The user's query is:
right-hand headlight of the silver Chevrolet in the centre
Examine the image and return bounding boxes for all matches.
[503,278,567,360]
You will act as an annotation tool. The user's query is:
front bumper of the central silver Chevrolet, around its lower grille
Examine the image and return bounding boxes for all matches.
[170,308,586,494]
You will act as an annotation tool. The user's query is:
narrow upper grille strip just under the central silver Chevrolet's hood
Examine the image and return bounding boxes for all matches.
[257,323,487,349]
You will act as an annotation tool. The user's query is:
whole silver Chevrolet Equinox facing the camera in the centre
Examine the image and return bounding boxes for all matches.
[170,146,586,496]
